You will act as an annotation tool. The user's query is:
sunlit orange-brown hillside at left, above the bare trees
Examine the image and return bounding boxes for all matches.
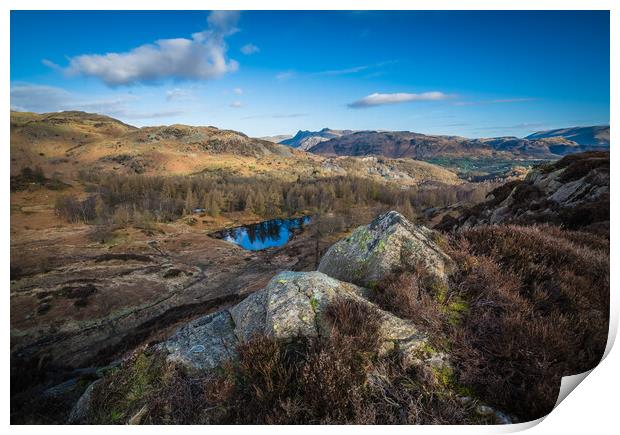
[11,112,310,179]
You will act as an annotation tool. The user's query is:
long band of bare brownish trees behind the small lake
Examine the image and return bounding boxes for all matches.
[55,173,490,226]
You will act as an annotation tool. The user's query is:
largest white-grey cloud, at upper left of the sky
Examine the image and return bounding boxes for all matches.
[55,11,239,86]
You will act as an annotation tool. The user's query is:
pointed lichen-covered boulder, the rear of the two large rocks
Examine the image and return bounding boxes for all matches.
[318,211,453,288]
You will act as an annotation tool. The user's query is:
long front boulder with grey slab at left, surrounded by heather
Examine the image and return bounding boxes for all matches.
[161,272,428,371]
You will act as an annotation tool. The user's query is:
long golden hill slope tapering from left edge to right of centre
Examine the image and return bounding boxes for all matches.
[11,112,460,184]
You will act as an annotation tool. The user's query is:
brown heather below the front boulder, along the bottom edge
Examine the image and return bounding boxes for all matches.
[82,300,484,424]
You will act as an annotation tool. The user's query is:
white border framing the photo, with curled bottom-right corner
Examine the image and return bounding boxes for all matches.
[0,0,620,435]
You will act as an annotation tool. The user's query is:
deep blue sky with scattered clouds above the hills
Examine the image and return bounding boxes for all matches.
[10,11,610,137]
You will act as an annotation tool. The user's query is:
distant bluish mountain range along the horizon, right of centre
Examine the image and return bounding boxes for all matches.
[310,127,608,160]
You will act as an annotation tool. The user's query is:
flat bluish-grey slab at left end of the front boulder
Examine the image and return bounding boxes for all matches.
[162,310,237,371]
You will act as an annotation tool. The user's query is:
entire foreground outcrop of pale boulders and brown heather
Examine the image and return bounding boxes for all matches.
[60,212,609,424]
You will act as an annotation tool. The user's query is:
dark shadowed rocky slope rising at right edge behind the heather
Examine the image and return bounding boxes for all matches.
[440,151,610,232]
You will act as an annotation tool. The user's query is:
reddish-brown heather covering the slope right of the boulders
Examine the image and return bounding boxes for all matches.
[377,226,609,420]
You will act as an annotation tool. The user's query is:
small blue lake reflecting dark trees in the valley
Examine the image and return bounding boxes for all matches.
[211,216,310,251]
